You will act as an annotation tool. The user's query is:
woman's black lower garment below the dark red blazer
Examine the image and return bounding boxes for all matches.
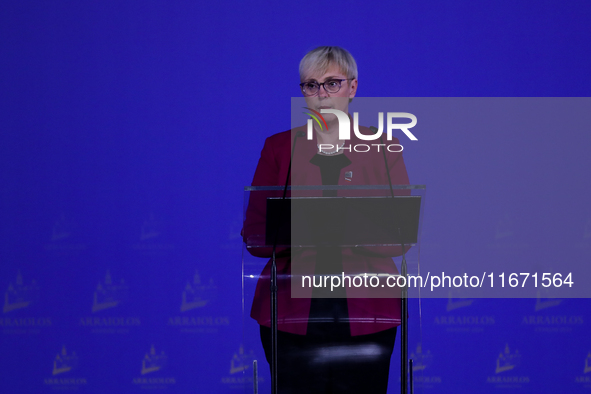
[260,326,396,394]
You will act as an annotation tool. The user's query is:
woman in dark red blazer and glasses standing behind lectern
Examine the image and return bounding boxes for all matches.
[243,46,409,394]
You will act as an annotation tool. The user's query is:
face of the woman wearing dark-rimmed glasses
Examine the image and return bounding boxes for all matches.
[302,65,357,123]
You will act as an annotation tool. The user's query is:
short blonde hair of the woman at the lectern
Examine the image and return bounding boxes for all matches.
[300,46,357,82]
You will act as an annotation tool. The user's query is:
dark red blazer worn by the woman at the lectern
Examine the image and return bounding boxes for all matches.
[243,127,409,336]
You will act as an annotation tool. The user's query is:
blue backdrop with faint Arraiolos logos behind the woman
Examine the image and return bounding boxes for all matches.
[0,0,591,393]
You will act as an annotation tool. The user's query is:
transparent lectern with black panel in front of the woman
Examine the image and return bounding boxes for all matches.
[239,185,425,393]
